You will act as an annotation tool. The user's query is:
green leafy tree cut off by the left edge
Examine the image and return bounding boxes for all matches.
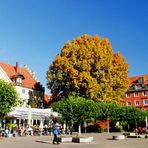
[0,79,18,116]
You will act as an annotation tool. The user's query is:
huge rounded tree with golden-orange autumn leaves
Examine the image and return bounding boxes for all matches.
[47,35,128,103]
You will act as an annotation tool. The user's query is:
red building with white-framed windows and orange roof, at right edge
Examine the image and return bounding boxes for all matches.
[125,75,148,110]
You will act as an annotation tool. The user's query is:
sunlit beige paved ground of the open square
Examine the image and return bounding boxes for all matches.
[0,133,148,148]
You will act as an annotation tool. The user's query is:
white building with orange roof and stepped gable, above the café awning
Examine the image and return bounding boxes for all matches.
[0,62,45,108]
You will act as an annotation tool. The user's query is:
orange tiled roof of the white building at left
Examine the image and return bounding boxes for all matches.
[0,63,37,88]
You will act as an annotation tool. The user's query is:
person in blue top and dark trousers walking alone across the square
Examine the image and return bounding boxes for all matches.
[52,123,59,144]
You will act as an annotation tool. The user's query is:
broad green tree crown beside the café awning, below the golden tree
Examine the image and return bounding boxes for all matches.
[51,96,98,134]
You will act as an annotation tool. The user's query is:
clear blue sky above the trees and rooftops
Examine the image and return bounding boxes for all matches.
[0,0,148,93]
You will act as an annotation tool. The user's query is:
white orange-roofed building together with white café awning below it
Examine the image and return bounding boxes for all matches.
[0,62,58,126]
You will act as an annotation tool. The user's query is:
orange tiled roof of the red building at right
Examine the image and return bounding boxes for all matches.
[129,74,148,86]
